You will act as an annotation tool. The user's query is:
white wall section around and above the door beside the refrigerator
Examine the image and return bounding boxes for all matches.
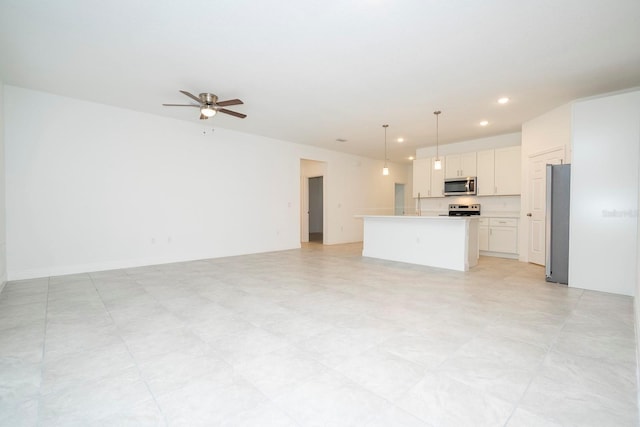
[518,104,571,262]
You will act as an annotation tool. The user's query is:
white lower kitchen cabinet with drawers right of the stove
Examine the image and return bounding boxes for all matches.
[478,217,518,258]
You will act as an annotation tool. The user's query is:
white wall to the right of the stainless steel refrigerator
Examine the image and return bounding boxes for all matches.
[569,90,640,295]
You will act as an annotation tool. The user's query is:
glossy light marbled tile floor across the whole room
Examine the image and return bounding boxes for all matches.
[0,244,638,427]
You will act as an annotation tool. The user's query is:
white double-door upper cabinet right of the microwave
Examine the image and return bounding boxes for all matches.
[476,146,521,196]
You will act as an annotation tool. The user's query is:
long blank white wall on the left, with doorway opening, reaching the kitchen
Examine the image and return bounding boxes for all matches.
[4,86,407,279]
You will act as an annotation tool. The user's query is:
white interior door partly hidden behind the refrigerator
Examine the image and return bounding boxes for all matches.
[527,148,564,265]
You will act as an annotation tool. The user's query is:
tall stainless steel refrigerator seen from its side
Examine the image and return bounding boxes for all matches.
[545,165,571,284]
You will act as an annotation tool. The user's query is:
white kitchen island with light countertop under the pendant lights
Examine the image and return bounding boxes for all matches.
[359,215,478,271]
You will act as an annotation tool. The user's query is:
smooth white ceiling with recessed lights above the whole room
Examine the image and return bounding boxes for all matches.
[0,0,640,161]
